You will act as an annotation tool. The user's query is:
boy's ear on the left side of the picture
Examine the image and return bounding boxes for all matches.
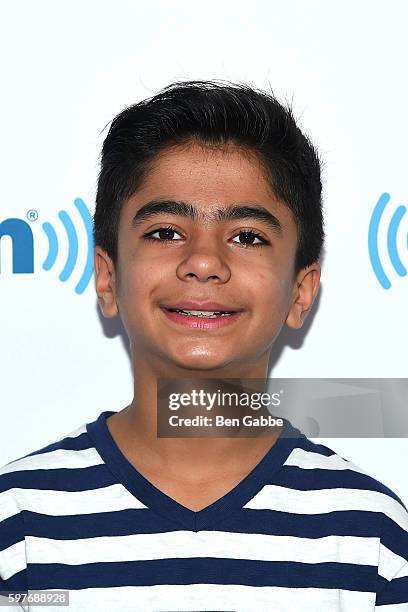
[94,246,119,318]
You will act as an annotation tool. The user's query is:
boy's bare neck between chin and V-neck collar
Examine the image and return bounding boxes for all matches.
[108,354,281,481]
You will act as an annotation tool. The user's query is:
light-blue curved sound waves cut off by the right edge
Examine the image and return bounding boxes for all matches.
[368,193,408,289]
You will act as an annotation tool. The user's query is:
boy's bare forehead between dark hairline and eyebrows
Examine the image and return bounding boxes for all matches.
[121,143,294,230]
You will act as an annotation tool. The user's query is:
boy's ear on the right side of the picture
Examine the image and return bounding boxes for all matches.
[286,263,321,329]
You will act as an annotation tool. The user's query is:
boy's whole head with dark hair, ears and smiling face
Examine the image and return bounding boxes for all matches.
[94,81,324,376]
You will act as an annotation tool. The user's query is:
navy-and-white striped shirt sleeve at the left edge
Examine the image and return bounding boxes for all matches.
[0,482,28,610]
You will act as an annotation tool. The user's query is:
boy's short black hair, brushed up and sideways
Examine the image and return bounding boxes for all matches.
[94,81,324,275]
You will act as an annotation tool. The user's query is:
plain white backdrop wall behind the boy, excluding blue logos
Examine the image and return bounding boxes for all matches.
[0,0,408,503]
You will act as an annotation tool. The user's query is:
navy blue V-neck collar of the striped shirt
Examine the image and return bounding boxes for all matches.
[86,410,305,531]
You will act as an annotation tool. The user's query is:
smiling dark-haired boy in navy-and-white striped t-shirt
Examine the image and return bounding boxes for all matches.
[0,81,408,612]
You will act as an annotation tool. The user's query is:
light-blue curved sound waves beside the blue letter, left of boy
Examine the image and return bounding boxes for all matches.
[42,198,94,294]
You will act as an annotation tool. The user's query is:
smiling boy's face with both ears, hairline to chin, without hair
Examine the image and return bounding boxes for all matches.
[95,144,320,372]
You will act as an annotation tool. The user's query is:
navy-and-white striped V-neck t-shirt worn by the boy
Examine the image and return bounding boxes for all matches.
[0,411,408,612]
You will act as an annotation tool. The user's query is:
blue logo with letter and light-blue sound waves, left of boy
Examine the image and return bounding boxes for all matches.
[0,198,94,294]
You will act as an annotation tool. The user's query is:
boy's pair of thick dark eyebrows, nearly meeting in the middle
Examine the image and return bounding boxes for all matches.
[131,200,283,236]
